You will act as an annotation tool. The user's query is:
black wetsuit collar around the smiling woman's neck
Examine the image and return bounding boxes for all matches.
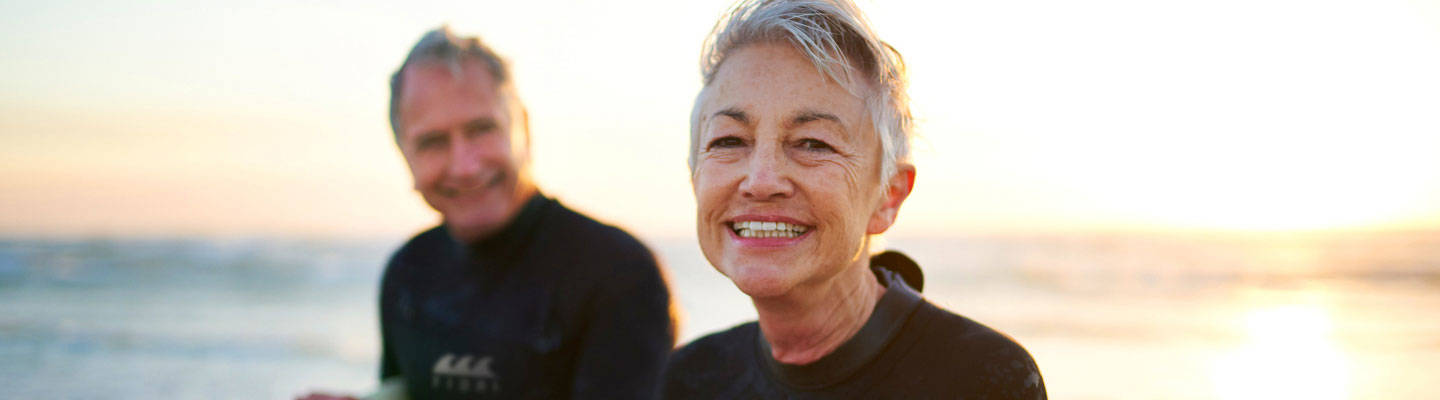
[756,252,920,388]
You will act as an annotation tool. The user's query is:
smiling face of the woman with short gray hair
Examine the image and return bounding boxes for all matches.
[693,45,913,298]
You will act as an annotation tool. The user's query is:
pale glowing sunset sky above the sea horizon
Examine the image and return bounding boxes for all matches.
[0,0,1440,237]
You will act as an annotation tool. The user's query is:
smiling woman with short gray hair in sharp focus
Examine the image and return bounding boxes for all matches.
[661,0,1045,399]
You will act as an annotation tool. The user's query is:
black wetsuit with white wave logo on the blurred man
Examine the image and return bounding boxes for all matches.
[380,194,675,399]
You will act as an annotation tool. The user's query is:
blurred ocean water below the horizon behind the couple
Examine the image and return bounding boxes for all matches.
[0,232,1440,400]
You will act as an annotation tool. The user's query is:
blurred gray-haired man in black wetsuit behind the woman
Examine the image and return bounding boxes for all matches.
[303,27,675,399]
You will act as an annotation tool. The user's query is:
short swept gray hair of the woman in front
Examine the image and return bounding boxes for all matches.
[690,0,914,180]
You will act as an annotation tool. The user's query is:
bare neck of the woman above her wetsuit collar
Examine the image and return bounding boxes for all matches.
[752,258,886,364]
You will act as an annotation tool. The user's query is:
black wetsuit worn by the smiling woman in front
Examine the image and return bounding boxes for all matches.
[661,252,1045,400]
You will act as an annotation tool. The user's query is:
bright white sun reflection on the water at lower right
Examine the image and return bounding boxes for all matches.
[1211,305,1351,400]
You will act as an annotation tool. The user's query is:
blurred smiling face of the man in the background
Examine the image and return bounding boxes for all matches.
[399,62,533,242]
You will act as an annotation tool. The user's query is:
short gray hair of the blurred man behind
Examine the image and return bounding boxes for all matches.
[390,26,530,142]
